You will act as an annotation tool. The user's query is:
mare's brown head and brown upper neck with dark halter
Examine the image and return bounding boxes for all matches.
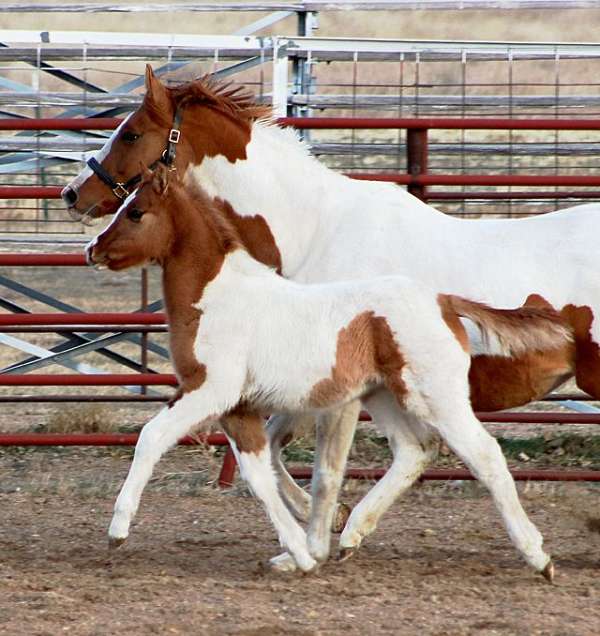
[61,66,267,218]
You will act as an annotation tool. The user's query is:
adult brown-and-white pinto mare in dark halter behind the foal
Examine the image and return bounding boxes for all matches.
[63,67,600,572]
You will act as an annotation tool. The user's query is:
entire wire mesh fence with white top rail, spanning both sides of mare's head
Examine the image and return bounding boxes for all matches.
[0,31,600,234]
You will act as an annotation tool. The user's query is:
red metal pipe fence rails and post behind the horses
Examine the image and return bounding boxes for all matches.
[0,117,600,485]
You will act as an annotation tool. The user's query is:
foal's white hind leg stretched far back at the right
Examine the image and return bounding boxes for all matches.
[422,394,553,580]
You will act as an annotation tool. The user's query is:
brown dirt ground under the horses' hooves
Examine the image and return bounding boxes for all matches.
[0,448,600,636]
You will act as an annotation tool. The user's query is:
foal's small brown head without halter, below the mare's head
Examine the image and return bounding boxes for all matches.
[85,164,176,271]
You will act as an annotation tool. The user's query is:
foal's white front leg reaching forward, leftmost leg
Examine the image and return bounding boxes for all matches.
[108,389,220,546]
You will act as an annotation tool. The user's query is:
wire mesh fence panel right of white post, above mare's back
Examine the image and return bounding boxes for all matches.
[291,38,600,217]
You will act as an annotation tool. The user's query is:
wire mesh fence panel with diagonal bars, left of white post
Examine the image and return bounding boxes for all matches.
[0,32,271,234]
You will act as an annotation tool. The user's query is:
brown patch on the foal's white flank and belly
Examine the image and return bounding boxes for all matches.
[308,311,407,407]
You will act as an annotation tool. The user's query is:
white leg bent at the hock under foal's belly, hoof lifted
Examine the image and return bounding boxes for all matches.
[340,391,438,560]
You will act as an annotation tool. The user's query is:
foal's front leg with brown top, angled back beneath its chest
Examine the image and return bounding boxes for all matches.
[222,413,317,572]
